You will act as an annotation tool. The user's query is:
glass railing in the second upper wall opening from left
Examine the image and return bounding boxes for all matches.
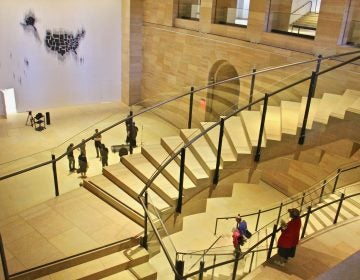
[214,8,249,27]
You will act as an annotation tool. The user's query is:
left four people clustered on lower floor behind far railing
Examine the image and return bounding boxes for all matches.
[66,129,109,178]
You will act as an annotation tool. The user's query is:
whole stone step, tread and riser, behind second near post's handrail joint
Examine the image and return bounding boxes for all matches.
[161,136,210,186]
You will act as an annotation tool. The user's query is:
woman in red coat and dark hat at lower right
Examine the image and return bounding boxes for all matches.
[274,208,301,266]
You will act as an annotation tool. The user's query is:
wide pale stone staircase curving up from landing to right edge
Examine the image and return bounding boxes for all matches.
[79,90,360,278]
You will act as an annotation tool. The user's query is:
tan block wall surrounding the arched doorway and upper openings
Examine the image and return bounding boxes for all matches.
[141,0,360,124]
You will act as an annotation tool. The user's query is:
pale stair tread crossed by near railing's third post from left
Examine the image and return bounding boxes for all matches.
[200,122,237,162]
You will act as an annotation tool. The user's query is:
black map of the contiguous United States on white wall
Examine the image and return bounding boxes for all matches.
[45,29,85,58]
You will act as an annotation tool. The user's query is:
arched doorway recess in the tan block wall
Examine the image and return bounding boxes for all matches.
[205,60,240,121]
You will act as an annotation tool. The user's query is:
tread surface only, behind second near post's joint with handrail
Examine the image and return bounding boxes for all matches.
[161,136,209,183]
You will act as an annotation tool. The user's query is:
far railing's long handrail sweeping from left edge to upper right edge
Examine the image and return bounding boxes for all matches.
[0,51,360,181]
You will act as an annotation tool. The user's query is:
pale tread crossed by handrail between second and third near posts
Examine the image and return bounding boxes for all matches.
[180,128,216,171]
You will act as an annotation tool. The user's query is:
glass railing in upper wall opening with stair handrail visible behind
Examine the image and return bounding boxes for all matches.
[267,12,318,39]
